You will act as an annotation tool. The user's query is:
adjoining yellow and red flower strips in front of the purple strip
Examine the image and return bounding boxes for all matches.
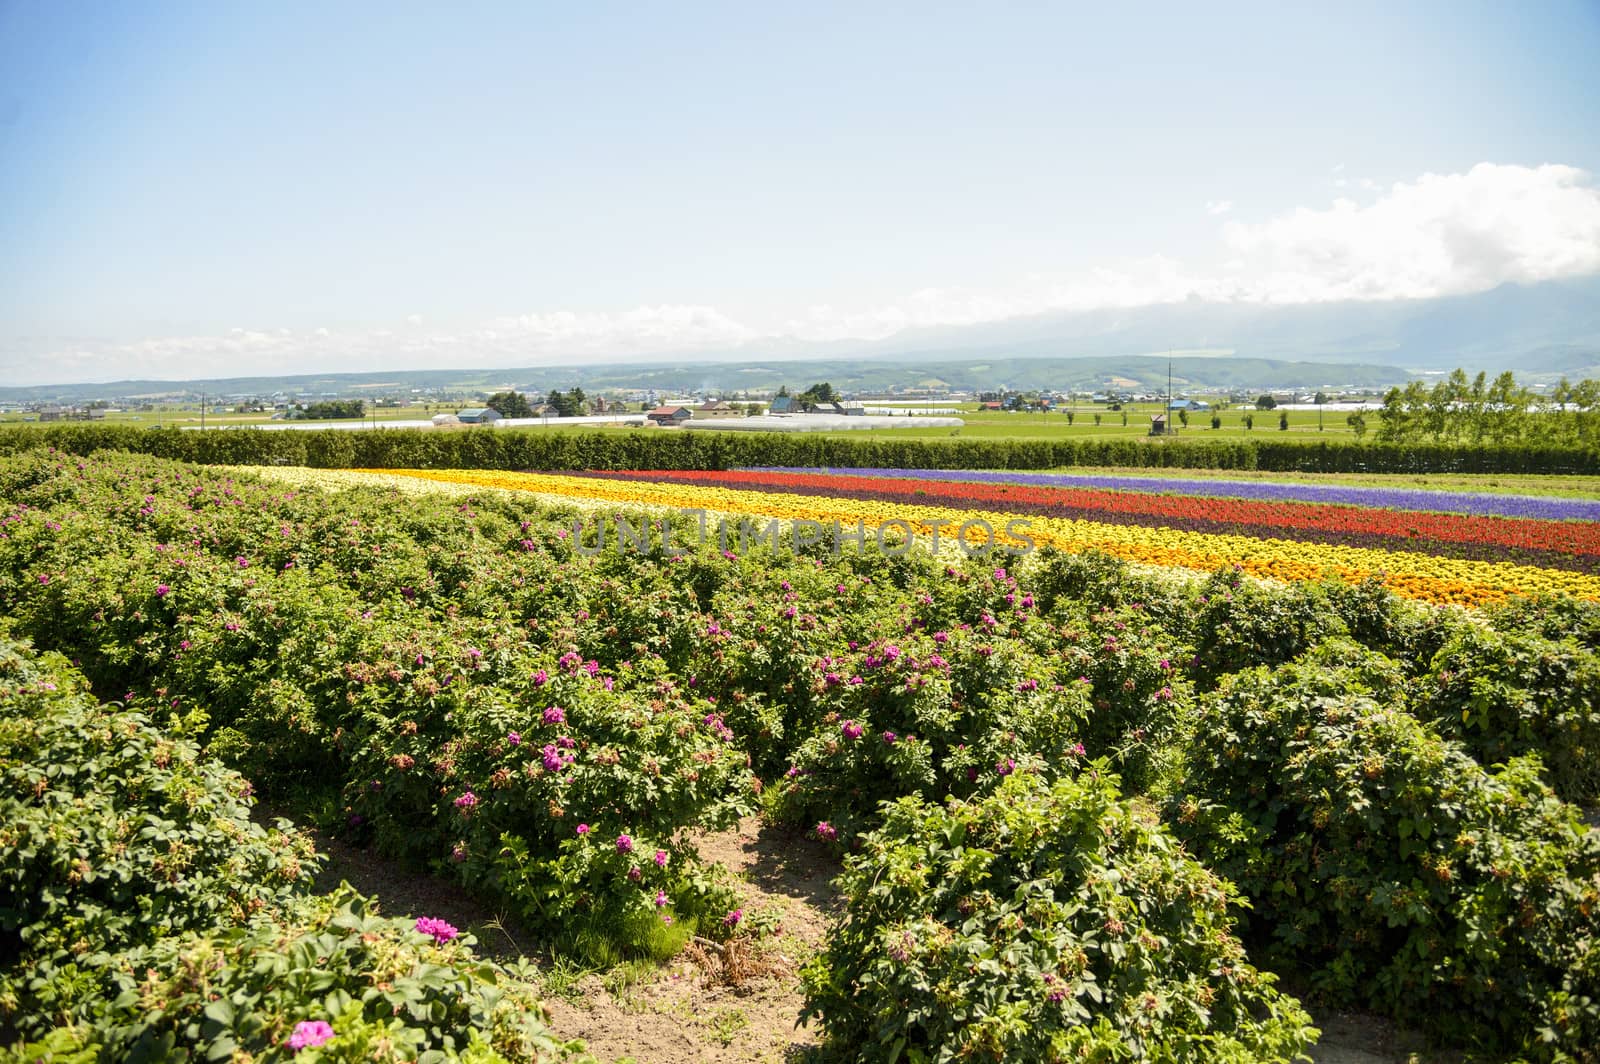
[356,470,1600,606]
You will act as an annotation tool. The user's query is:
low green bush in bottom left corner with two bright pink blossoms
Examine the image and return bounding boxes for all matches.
[0,886,589,1064]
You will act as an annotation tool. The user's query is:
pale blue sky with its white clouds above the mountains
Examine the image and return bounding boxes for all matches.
[0,0,1600,384]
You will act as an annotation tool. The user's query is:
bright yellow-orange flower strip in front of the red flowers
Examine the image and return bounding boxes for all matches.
[362,469,1600,606]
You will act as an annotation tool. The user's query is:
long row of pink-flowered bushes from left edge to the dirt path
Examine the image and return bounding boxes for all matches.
[0,454,755,955]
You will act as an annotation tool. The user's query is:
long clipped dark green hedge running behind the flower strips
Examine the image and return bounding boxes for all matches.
[0,424,1600,475]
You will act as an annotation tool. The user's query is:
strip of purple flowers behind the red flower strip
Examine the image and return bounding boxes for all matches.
[749,466,1600,522]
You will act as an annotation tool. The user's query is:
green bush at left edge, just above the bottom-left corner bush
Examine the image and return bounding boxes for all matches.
[0,640,318,1018]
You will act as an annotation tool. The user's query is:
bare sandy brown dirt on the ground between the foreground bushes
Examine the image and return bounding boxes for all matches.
[308,816,1459,1064]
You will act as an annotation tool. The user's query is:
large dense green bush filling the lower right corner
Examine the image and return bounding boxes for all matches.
[1170,643,1600,1061]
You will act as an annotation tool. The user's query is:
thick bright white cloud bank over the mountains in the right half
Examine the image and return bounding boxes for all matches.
[787,163,1600,332]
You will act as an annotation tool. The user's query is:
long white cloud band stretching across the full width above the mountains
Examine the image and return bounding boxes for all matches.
[12,163,1600,384]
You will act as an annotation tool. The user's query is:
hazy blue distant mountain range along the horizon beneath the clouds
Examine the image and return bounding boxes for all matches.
[0,277,1600,403]
